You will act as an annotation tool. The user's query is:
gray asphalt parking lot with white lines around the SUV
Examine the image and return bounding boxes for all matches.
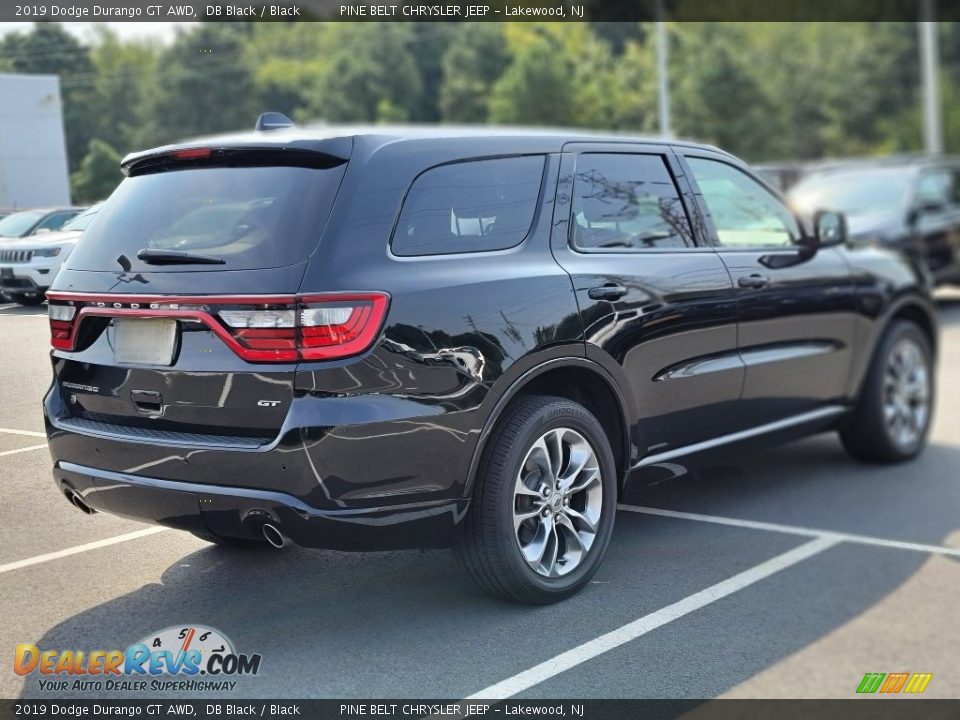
[0,293,960,699]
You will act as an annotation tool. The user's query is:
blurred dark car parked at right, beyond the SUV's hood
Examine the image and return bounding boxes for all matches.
[789,156,960,285]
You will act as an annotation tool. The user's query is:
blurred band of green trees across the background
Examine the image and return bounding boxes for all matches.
[0,22,960,202]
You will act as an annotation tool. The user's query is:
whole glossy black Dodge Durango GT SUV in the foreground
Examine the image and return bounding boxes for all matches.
[44,118,937,603]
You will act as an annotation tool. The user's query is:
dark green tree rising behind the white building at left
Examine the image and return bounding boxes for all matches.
[0,22,97,168]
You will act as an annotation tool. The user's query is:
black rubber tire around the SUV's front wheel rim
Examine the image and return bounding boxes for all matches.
[840,320,935,463]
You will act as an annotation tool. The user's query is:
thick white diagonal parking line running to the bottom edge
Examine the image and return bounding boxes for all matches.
[465,537,840,701]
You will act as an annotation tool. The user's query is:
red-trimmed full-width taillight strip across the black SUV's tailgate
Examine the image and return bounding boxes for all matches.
[48,292,390,362]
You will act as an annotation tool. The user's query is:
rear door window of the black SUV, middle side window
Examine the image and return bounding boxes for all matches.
[572,153,694,252]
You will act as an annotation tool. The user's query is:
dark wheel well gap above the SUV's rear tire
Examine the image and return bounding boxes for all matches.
[511,366,629,491]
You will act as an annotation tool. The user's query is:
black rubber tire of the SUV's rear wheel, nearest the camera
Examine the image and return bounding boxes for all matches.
[454,396,617,605]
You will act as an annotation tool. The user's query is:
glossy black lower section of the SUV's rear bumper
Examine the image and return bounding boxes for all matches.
[53,461,469,550]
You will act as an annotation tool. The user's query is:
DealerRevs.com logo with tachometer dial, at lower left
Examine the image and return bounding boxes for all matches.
[13,625,262,692]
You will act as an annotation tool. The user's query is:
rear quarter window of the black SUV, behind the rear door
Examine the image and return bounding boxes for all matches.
[391,156,544,256]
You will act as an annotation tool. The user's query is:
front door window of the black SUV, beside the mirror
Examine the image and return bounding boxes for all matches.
[687,157,800,248]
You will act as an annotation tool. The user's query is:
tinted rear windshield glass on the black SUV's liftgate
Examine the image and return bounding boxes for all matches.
[67,165,346,272]
